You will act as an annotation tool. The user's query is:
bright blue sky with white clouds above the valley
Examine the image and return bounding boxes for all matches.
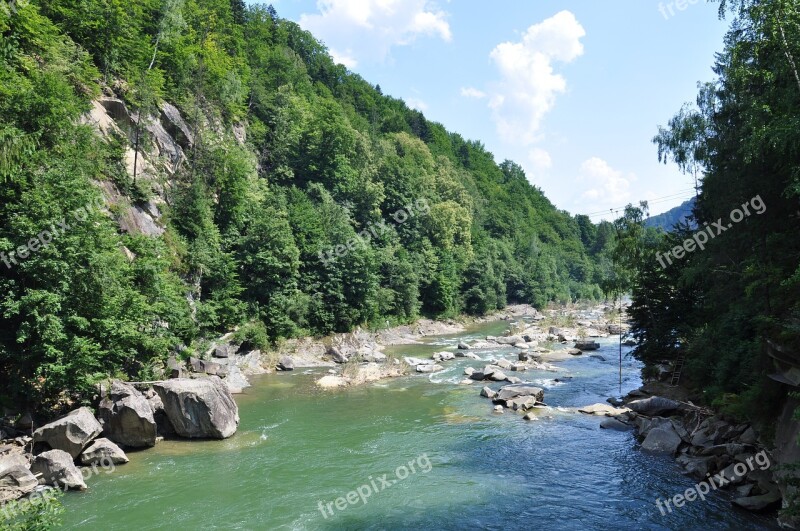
[253,0,728,222]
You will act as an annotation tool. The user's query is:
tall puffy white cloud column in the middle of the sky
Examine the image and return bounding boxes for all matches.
[489,11,586,145]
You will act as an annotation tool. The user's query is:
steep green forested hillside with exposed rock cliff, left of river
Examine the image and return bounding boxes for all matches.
[0,0,612,412]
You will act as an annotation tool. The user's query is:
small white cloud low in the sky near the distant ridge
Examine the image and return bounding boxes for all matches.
[576,157,636,212]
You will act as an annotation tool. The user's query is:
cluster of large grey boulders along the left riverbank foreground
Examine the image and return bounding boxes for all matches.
[0,376,239,512]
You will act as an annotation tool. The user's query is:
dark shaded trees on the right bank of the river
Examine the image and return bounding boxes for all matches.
[615,0,800,424]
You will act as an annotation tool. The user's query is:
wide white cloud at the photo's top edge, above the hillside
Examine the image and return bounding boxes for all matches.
[299,0,453,66]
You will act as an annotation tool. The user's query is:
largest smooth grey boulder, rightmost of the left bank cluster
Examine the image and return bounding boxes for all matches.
[153,376,239,439]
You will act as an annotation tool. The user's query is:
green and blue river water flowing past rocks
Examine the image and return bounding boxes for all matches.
[59,322,776,531]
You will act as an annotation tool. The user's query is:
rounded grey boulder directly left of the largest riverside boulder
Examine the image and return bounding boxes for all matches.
[97,381,157,448]
